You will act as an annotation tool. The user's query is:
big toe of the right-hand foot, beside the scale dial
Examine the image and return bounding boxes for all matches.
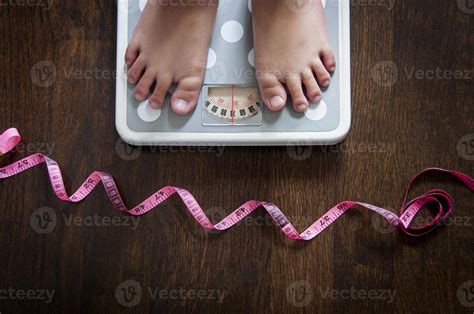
[258,75,287,111]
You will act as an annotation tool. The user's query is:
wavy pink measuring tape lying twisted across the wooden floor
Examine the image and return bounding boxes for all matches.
[0,129,474,241]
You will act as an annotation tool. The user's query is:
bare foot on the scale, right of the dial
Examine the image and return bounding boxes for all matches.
[252,0,336,112]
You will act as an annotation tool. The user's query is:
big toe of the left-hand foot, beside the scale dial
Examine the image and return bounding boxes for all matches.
[171,76,203,115]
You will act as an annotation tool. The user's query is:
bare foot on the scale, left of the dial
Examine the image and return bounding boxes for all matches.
[125,1,217,114]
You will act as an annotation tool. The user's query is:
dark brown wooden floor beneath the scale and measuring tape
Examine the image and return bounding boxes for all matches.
[0,0,474,314]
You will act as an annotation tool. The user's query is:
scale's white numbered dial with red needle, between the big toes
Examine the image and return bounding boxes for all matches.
[205,85,262,121]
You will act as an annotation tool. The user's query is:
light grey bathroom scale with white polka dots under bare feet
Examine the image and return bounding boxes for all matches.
[116,0,351,146]
